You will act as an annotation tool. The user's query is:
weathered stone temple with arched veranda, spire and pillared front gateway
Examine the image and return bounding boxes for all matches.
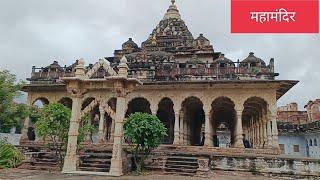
[21,0,319,176]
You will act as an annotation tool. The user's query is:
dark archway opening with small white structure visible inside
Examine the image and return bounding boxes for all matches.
[210,96,236,147]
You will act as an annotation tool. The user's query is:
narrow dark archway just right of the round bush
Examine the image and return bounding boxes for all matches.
[157,97,175,144]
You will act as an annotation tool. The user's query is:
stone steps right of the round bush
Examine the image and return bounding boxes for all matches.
[164,154,199,176]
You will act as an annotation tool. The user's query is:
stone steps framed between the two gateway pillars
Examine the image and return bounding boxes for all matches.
[78,149,112,172]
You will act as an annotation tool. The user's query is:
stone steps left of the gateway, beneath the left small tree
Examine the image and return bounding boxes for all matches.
[19,152,60,171]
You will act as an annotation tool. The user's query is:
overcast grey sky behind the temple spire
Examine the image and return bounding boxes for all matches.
[0,0,320,109]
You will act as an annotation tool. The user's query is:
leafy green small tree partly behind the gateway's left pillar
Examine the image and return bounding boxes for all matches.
[35,103,92,168]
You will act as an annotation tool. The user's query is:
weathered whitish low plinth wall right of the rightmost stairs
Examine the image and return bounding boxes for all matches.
[210,156,320,176]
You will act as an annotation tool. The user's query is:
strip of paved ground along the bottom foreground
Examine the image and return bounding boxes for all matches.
[0,169,290,180]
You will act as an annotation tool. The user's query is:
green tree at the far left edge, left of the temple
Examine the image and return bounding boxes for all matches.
[0,70,28,132]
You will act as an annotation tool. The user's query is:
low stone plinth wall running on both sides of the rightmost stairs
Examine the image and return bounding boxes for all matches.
[147,152,320,178]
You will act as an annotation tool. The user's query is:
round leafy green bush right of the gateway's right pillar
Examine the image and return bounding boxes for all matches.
[124,112,167,173]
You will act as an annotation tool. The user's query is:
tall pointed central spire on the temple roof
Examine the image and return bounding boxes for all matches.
[141,0,194,52]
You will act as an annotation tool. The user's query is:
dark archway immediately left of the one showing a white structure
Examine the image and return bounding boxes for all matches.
[180,96,205,146]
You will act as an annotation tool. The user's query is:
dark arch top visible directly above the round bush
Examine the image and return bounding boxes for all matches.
[126,97,151,117]
